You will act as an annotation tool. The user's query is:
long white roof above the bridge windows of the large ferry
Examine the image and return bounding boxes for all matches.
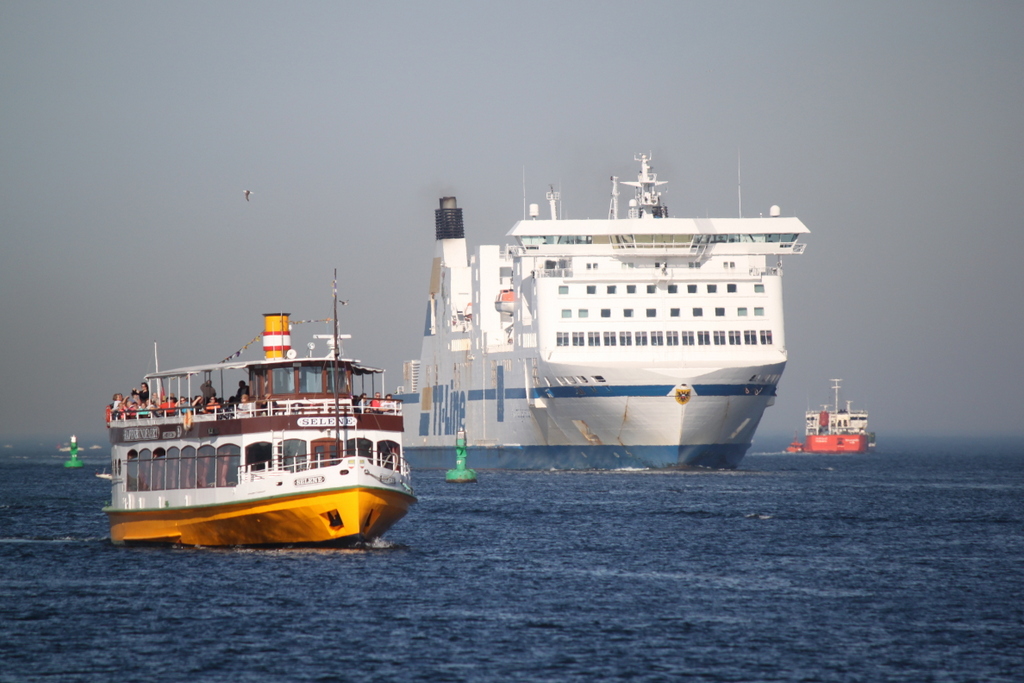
[506,216,810,238]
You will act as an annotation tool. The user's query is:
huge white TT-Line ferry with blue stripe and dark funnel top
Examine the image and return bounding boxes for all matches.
[402,155,809,469]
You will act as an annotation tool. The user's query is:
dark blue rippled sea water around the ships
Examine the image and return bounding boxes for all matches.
[0,439,1024,682]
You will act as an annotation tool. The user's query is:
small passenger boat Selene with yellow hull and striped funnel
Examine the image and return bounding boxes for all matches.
[104,313,416,546]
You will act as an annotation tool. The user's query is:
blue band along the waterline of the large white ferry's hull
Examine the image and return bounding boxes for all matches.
[406,443,751,470]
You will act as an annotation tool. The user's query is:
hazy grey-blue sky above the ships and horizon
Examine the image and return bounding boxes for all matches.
[0,0,1024,442]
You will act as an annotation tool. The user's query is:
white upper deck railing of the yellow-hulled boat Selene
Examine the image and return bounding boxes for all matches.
[108,398,402,425]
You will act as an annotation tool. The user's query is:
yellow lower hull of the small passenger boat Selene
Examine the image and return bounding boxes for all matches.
[105,488,416,546]
